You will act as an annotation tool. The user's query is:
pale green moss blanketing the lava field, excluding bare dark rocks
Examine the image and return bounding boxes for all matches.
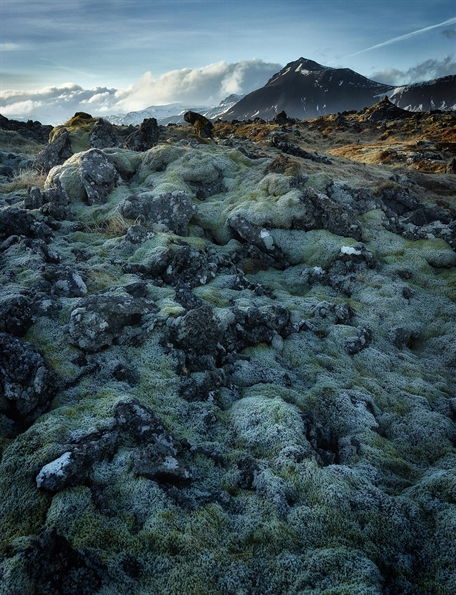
[0,137,456,595]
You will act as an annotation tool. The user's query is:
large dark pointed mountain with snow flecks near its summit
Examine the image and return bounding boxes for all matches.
[223,58,394,120]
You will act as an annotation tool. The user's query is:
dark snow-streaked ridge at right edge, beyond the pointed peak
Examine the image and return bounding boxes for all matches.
[390,75,456,112]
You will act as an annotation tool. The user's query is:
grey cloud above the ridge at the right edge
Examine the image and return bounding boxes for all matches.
[370,55,456,85]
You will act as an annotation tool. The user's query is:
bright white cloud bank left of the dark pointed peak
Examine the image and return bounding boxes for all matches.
[0,59,282,124]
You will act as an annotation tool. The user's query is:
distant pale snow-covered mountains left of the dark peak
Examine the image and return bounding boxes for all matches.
[104,93,242,126]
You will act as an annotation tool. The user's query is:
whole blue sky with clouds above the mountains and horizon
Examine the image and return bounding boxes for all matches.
[0,0,456,124]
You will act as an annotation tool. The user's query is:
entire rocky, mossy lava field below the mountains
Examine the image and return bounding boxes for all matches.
[0,105,456,595]
